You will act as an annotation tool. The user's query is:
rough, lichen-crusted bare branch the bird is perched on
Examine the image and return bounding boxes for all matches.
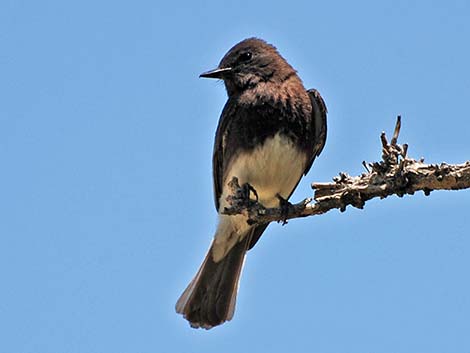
[224,116,470,224]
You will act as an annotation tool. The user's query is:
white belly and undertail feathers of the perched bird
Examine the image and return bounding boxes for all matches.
[213,134,306,262]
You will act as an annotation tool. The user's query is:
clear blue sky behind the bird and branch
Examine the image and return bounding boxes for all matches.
[0,0,470,353]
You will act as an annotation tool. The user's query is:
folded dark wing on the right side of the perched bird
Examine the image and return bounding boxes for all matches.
[304,88,327,175]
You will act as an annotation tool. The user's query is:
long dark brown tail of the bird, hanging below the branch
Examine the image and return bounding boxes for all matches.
[176,232,252,329]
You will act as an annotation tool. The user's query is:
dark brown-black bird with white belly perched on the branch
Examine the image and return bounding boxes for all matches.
[176,38,326,329]
